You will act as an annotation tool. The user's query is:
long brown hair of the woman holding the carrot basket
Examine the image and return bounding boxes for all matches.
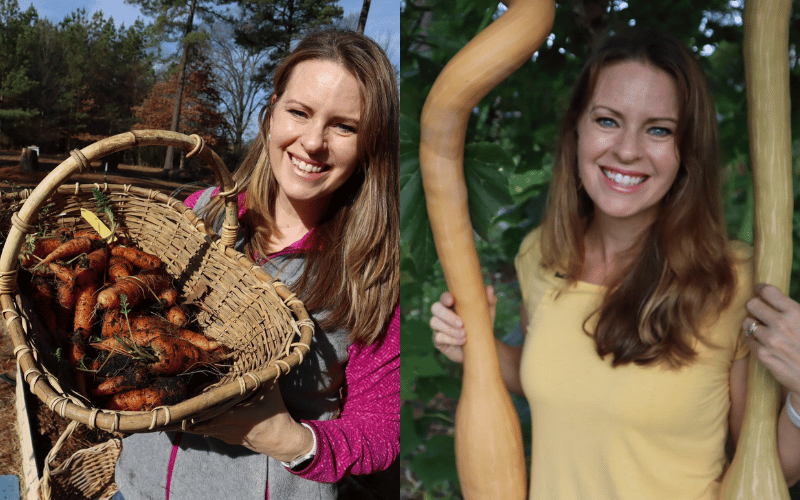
[202,30,400,344]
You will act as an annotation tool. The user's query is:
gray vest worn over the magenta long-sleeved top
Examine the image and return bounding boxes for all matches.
[115,190,349,500]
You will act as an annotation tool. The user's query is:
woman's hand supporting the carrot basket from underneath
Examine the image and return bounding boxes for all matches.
[189,382,314,462]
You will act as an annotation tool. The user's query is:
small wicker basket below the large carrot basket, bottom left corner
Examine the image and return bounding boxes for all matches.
[39,420,122,500]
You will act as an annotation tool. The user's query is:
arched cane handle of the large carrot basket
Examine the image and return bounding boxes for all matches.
[4,130,239,250]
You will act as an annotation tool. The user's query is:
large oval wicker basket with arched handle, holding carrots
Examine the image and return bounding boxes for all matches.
[0,130,314,433]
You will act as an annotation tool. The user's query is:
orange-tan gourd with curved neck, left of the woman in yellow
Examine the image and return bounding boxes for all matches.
[420,0,555,500]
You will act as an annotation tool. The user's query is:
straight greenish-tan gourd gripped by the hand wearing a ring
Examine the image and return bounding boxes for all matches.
[721,0,793,500]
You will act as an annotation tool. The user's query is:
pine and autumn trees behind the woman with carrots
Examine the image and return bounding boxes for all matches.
[0,0,399,180]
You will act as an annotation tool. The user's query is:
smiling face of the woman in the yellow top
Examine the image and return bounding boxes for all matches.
[577,61,680,228]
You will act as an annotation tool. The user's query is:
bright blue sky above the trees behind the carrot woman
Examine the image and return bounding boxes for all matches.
[19,0,400,66]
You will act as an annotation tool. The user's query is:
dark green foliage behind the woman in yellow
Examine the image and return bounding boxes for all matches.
[400,0,800,500]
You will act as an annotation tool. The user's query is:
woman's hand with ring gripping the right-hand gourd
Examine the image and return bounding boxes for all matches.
[742,284,800,394]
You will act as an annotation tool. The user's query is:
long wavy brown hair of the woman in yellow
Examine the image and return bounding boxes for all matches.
[542,29,736,367]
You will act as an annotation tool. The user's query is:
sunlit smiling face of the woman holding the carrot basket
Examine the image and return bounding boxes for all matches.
[269,59,361,211]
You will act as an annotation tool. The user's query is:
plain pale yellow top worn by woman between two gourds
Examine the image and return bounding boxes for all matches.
[516,229,752,500]
